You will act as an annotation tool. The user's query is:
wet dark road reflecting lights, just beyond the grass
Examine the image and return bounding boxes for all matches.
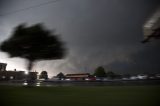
[0,79,160,86]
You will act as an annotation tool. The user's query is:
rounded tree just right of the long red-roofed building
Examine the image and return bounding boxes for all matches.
[93,66,106,77]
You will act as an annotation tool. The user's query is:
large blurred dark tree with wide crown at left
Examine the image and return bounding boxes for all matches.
[0,24,65,71]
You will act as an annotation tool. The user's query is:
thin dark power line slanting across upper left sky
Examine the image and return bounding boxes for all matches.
[0,0,60,16]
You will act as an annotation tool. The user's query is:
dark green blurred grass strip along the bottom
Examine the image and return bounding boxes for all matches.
[0,86,160,106]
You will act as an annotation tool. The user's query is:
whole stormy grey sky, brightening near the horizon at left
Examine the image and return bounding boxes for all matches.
[0,0,160,76]
